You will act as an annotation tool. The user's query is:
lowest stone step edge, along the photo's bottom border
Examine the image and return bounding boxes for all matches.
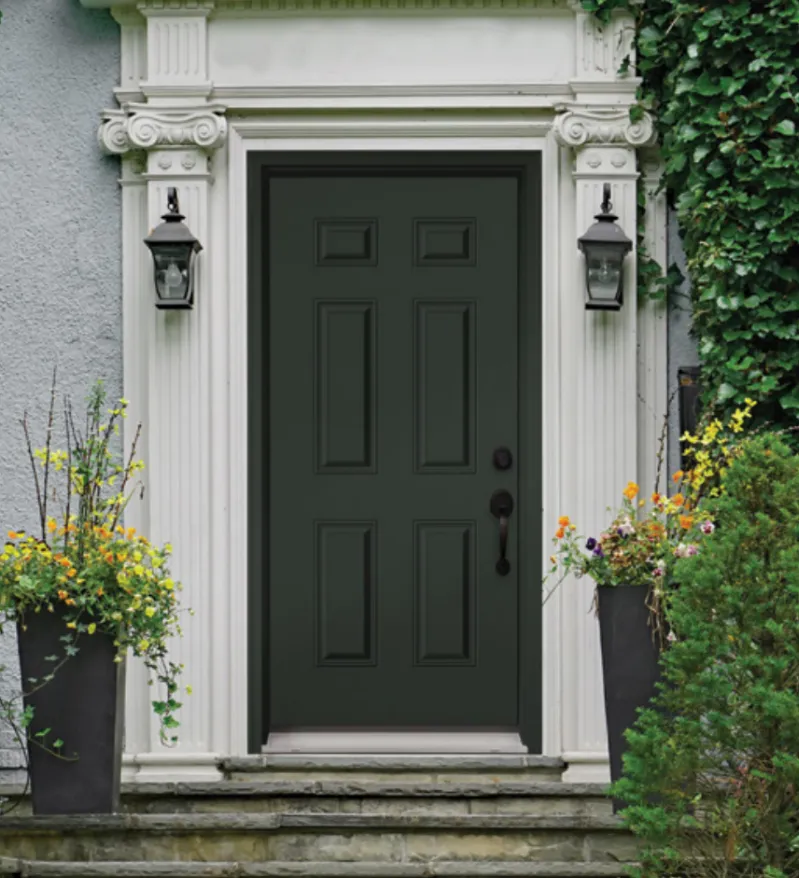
[0,860,627,878]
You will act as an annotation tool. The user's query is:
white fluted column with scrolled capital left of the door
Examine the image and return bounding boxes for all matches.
[99,0,228,781]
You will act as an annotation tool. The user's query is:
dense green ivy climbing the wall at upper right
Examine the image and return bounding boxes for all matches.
[582,0,799,436]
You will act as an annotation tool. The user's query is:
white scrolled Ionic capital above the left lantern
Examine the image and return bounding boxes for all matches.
[98,103,228,155]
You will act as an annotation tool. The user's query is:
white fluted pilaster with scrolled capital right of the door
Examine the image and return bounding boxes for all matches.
[555,105,652,780]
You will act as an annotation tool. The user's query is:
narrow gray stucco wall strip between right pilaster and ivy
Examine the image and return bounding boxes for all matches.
[668,213,699,482]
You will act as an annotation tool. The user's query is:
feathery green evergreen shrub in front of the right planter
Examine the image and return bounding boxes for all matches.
[614,434,799,878]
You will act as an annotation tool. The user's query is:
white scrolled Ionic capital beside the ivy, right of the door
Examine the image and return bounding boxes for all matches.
[554,104,655,148]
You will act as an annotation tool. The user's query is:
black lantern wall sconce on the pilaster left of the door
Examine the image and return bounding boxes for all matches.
[144,186,203,309]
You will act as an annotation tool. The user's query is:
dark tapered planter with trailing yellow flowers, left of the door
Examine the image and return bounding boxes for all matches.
[17,608,125,814]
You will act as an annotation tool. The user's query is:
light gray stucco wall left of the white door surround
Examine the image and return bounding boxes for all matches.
[0,0,122,776]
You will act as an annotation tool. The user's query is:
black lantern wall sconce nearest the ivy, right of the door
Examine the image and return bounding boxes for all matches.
[577,183,633,311]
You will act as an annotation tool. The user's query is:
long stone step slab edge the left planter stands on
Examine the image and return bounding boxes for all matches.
[0,811,626,836]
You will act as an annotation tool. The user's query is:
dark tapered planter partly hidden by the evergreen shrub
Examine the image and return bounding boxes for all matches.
[597,585,660,813]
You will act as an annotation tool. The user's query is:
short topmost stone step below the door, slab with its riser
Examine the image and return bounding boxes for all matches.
[220,753,565,783]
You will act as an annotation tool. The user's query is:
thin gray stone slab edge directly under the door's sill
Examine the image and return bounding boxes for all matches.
[219,753,566,773]
